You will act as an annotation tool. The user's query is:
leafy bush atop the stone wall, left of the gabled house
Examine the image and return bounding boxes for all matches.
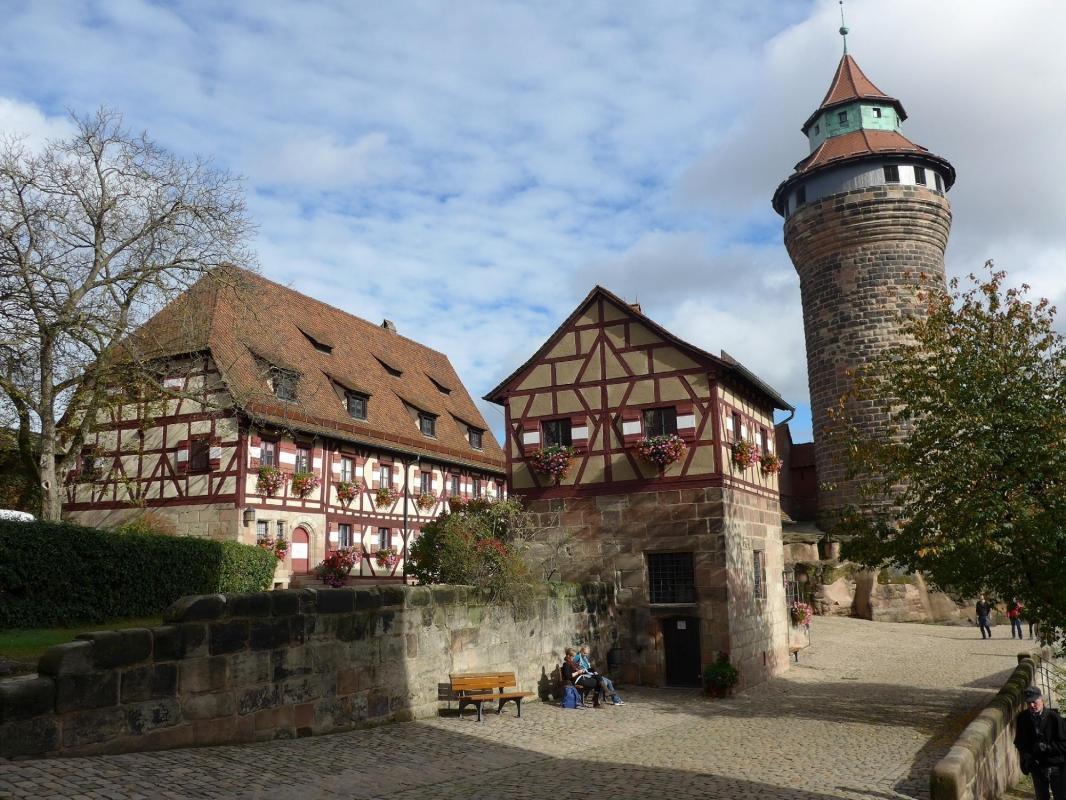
[407,499,533,598]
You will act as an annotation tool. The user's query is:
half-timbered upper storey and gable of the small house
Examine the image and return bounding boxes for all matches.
[485,287,791,499]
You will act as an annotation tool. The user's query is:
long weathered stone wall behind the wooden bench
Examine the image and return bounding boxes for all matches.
[0,585,615,757]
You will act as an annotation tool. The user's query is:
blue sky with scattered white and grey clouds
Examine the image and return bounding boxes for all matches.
[0,0,1066,442]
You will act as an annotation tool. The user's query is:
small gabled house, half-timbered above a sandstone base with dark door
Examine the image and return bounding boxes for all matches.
[486,287,791,685]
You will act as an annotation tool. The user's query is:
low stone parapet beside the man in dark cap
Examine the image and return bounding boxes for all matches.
[930,651,1048,800]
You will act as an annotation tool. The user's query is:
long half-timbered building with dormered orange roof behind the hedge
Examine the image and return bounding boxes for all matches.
[64,270,505,586]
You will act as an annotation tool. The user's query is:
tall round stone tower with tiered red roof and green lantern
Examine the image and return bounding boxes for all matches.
[773,51,955,524]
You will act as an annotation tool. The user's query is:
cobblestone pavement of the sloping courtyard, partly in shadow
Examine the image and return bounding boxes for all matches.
[0,618,1031,800]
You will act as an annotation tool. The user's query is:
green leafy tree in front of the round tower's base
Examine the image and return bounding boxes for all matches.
[835,262,1066,636]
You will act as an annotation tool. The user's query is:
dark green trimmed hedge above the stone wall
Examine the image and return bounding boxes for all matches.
[0,521,277,628]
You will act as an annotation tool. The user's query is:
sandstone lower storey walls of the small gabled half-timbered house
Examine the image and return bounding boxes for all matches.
[529,487,788,686]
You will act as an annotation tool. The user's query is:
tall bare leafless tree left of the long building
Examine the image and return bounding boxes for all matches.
[0,109,252,519]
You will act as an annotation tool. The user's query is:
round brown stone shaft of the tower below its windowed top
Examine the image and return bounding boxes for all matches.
[785,186,951,522]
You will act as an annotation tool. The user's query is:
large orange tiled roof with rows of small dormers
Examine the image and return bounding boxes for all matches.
[138,269,503,470]
